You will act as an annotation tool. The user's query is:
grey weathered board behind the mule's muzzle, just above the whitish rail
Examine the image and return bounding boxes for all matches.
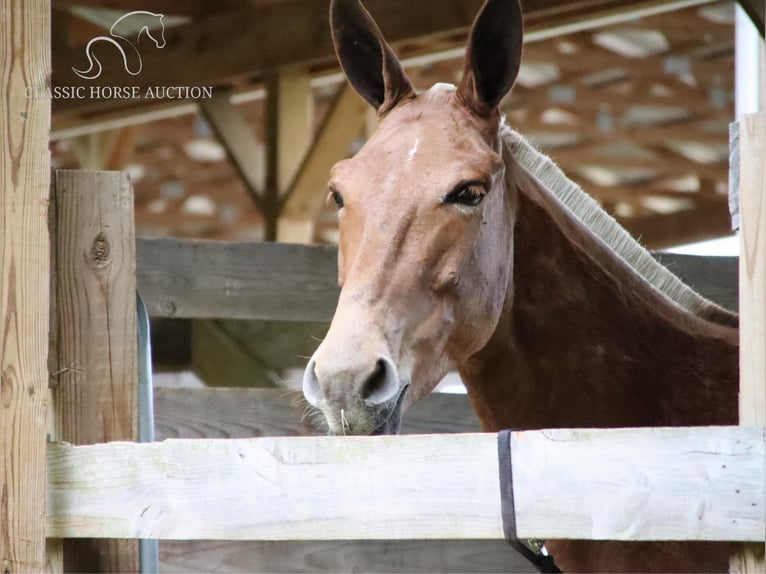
[154,388,480,440]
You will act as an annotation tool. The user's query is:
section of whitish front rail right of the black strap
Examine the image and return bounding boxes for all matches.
[511,427,764,540]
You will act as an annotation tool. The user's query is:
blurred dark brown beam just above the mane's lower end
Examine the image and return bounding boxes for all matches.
[618,197,731,249]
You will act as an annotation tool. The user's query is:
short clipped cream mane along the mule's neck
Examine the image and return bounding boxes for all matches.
[501,124,736,326]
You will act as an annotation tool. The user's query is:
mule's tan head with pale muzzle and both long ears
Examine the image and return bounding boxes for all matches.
[303,0,522,434]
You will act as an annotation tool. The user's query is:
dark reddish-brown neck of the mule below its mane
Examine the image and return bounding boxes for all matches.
[460,160,738,430]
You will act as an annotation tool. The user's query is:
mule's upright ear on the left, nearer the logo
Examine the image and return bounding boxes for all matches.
[330,0,415,114]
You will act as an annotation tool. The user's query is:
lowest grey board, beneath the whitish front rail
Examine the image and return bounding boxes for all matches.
[160,540,536,574]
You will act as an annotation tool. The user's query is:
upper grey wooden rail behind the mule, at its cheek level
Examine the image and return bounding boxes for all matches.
[136,239,737,321]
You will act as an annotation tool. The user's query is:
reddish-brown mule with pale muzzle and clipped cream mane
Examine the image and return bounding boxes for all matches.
[303,0,738,572]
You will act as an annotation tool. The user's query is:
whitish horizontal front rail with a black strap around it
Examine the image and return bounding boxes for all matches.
[47,427,764,541]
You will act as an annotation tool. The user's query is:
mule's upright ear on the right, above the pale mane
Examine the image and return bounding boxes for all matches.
[458,0,524,115]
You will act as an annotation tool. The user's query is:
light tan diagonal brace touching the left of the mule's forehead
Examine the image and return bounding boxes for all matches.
[282,84,368,238]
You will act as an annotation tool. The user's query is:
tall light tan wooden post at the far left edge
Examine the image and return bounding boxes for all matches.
[0,0,51,574]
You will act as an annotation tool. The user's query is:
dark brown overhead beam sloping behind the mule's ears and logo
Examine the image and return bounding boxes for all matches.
[53,0,724,118]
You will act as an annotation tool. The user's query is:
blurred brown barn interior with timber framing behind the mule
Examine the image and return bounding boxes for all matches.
[51,0,765,386]
